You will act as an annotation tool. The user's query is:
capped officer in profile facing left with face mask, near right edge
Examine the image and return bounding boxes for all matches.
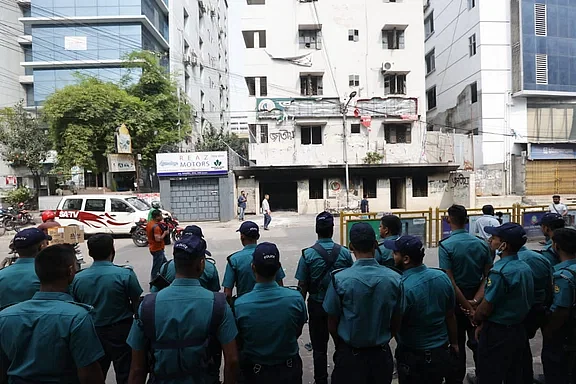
[474,223,534,384]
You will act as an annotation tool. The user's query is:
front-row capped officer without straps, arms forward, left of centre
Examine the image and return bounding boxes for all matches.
[234,243,308,384]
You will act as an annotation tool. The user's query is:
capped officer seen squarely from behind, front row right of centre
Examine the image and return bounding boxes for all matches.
[324,223,402,384]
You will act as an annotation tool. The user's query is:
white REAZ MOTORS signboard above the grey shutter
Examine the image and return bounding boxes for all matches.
[156,151,228,177]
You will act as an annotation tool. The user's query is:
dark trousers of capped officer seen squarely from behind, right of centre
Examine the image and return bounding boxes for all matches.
[332,341,394,384]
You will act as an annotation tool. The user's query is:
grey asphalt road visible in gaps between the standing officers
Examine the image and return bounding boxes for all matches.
[0,214,542,383]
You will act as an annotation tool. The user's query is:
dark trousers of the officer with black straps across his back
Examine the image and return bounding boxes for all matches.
[308,299,330,384]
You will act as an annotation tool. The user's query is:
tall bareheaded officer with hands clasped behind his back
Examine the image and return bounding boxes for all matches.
[438,205,492,383]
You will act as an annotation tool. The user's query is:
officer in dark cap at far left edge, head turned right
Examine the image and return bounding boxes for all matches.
[0,228,52,308]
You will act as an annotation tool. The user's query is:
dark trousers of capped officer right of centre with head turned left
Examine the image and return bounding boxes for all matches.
[396,345,458,384]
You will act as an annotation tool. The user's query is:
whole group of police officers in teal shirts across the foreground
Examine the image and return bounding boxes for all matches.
[0,205,576,384]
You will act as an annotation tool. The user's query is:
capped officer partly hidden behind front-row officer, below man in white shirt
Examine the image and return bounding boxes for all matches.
[222,221,286,301]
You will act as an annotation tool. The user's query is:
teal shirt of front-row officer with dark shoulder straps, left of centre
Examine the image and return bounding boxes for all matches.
[127,279,238,384]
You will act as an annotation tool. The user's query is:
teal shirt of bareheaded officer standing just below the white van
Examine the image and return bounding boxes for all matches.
[70,261,142,327]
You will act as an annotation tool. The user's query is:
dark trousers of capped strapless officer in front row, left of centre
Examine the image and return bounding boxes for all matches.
[241,355,302,384]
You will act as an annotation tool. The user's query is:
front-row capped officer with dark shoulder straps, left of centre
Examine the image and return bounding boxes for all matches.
[127,236,238,384]
